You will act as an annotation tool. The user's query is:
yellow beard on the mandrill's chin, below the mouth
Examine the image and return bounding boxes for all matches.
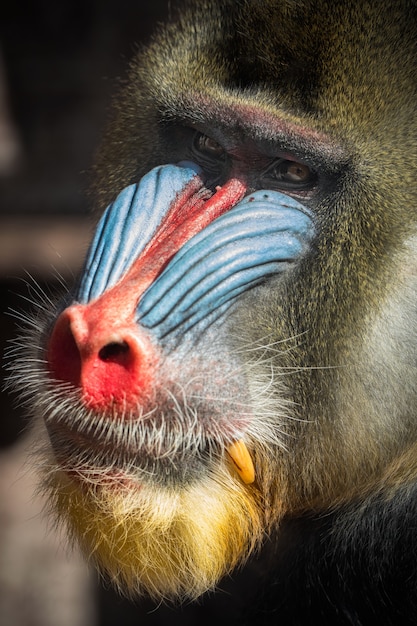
[48,465,262,599]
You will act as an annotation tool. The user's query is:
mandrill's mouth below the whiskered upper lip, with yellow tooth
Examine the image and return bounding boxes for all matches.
[47,414,255,489]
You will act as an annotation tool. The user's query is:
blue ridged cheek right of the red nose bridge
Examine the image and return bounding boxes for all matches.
[137,190,314,343]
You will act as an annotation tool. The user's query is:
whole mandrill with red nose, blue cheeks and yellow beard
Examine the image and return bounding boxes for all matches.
[11,0,417,626]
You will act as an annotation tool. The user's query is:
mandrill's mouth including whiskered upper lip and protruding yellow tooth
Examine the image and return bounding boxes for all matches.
[45,356,255,486]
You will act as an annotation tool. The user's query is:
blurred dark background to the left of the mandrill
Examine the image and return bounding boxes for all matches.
[0,0,260,626]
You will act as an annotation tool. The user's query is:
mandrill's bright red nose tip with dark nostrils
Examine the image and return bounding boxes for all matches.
[48,298,158,410]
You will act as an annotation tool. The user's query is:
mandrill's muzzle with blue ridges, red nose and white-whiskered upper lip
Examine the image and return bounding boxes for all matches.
[47,163,314,484]
